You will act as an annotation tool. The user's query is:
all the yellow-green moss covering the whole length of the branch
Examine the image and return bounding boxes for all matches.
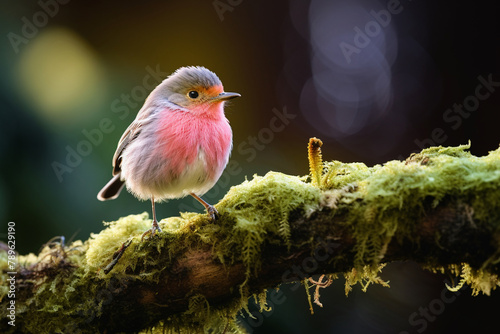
[0,145,500,333]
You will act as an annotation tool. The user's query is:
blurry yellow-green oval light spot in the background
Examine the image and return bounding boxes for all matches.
[16,28,106,126]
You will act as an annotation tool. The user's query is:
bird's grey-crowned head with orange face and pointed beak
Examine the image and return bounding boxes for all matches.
[157,66,241,112]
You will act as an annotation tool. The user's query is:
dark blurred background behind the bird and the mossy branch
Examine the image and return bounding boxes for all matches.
[0,0,500,333]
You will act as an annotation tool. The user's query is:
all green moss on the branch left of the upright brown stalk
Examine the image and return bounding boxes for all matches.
[0,172,320,333]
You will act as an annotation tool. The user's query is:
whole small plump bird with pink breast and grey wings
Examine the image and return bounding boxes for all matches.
[97,66,241,238]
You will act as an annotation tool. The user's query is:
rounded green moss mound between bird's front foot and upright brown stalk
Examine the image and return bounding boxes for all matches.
[216,172,320,278]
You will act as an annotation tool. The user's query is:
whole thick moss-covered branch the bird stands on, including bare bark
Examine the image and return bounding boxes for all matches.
[0,142,500,333]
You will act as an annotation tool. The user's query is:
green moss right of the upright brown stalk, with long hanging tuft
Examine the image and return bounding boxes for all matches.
[322,145,500,282]
